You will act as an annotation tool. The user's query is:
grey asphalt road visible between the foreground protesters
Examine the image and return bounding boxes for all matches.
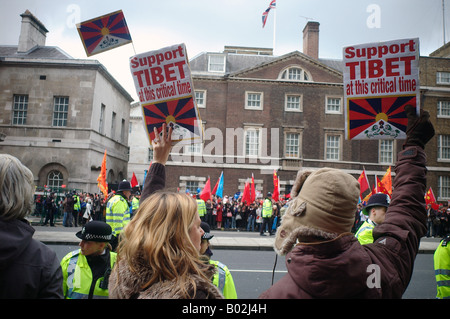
[49,245,436,299]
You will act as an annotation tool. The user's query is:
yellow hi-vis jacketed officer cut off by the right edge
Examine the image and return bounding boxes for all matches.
[434,235,450,299]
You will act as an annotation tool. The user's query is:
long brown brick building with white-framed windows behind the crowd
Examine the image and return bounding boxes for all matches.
[129,22,450,201]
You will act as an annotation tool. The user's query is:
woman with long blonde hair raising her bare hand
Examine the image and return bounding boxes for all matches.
[109,125,223,299]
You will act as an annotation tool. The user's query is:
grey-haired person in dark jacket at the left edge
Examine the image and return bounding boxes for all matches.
[0,154,63,299]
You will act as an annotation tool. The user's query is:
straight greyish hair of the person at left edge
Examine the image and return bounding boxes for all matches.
[0,154,34,220]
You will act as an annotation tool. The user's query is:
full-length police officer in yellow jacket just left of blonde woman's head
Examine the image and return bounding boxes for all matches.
[106,180,131,251]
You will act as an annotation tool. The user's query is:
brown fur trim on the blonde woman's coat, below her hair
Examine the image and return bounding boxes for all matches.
[109,260,223,299]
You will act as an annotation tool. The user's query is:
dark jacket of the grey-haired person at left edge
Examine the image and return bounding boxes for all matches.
[0,218,64,299]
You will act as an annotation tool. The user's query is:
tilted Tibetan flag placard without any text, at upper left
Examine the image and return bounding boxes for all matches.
[77,10,132,56]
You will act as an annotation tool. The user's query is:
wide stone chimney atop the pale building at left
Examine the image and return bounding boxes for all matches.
[17,10,48,53]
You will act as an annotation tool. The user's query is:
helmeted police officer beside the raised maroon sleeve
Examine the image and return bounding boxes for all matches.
[355,193,391,245]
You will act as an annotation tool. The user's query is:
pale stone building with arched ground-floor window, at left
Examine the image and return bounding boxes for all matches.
[0,10,133,192]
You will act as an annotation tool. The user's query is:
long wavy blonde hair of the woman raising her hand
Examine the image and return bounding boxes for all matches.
[118,192,209,298]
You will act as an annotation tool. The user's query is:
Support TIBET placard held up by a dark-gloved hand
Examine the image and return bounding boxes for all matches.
[343,38,420,139]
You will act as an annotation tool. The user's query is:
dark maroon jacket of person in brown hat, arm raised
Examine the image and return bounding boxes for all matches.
[260,147,426,298]
